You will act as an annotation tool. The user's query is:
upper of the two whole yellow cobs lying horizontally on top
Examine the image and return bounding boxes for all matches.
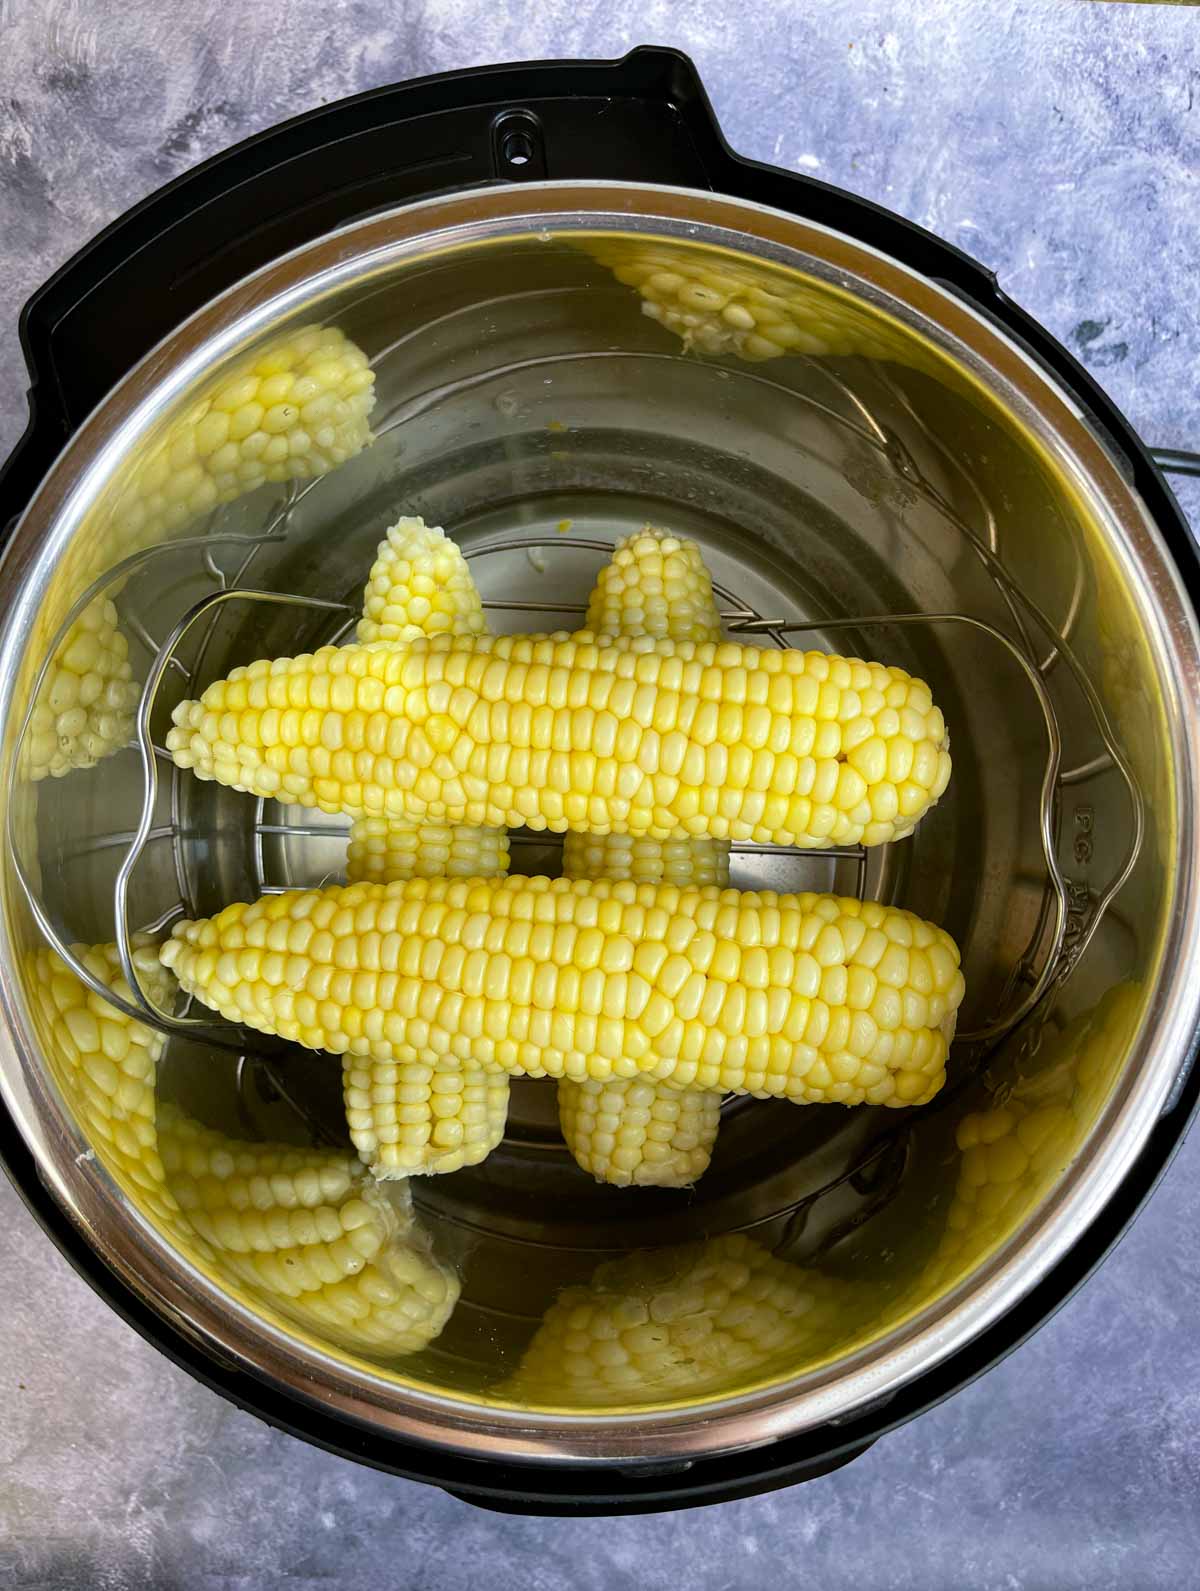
[167,632,950,846]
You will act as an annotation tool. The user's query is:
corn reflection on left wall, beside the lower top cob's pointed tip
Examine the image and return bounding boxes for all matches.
[29,943,180,1230]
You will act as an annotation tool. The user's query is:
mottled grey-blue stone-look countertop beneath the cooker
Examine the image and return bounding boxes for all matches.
[0,0,1200,1591]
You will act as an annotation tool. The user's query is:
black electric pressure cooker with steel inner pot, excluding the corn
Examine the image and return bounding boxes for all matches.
[0,49,1200,1513]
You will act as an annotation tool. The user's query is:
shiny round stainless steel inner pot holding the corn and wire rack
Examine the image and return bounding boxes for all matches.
[0,183,1200,1465]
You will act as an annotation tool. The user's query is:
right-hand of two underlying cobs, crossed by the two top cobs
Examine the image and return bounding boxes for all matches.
[559,525,729,1187]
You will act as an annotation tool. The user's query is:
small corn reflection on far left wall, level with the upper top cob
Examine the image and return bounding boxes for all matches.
[21,597,140,780]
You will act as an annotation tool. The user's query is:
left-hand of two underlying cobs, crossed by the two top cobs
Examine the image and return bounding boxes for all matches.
[344,519,508,1177]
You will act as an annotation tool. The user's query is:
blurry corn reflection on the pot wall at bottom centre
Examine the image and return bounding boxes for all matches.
[498,1235,859,1408]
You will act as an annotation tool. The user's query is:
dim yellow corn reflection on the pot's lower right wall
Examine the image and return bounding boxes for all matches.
[920,983,1143,1297]
